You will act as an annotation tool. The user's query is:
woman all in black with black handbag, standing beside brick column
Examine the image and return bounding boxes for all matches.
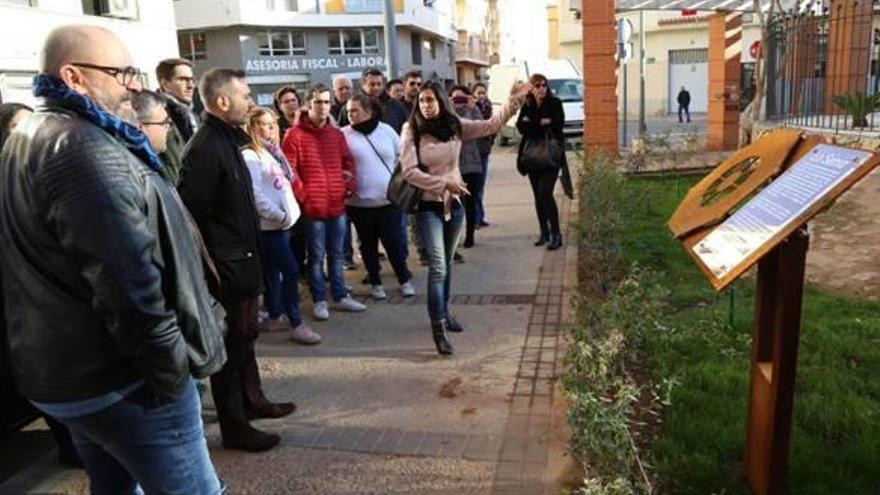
[516,74,573,251]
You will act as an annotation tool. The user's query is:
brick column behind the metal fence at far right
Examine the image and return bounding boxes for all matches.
[825,0,873,114]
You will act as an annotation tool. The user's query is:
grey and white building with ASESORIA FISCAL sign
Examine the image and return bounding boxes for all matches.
[174,0,455,105]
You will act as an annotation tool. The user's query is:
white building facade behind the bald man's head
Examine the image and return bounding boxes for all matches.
[0,0,177,104]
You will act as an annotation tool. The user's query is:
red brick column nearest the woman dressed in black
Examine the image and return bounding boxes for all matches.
[582,0,617,155]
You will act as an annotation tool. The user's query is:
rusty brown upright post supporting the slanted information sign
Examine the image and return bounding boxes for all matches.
[743,227,809,495]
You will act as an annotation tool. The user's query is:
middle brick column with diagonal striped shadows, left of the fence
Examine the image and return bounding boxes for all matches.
[706,12,742,151]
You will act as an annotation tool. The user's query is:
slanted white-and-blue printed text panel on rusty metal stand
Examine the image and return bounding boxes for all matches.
[692,144,876,289]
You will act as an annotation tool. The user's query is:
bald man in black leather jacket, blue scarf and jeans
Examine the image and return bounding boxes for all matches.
[0,26,226,494]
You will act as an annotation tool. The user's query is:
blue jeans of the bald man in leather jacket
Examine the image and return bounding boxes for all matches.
[62,380,220,495]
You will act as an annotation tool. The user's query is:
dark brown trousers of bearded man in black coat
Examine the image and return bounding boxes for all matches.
[211,296,268,435]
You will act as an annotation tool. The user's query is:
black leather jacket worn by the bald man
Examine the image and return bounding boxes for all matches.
[0,100,226,402]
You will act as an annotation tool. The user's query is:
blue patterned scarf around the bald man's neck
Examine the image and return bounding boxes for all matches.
[33,74,163,172]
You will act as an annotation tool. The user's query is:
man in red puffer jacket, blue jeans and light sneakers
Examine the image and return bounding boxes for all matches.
[282,85,367,321]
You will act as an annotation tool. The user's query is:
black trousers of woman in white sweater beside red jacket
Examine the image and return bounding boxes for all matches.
[346,205,412,285]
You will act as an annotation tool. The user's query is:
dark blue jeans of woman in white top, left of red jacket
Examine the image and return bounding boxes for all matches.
[261,230,302,327]
